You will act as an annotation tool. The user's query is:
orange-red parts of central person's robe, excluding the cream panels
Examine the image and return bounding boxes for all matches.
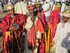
[26,17,44,52]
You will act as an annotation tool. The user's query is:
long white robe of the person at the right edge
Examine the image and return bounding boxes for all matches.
[54,22,70,53]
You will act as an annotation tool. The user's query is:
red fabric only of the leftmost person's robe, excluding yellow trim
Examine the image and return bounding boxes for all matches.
[2,14,25,53]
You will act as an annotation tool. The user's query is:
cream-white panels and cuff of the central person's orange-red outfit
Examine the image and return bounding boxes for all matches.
[25,17,42,53]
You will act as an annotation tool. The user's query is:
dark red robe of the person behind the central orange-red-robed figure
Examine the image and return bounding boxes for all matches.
[38,12,48,53]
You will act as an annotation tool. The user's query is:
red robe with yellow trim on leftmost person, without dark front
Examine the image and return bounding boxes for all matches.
[2,14,25,53]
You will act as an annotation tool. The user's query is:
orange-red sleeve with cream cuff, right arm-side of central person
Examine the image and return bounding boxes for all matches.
[36,19,44,39]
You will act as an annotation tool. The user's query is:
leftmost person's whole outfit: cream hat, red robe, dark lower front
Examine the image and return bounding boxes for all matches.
[2,6,26,53]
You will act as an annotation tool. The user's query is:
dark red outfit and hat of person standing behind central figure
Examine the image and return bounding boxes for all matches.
[35,3,48,53]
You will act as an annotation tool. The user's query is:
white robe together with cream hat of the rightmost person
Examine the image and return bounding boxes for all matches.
[54,12,70,53]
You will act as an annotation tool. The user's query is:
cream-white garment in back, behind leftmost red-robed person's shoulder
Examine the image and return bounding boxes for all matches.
[15,1,27,14]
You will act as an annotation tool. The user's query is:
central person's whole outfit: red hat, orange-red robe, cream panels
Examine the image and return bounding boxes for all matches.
[25,5,44,53]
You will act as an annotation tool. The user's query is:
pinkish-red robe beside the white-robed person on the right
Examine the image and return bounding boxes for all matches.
[49,10,60,45]
